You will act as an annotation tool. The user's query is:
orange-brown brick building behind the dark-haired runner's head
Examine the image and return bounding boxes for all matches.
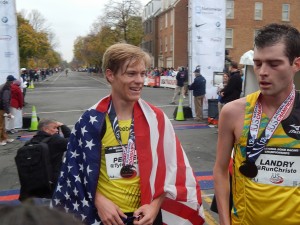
[226,0,300,62]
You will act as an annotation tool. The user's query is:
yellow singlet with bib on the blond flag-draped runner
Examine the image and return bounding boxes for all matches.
[97,115,140,212]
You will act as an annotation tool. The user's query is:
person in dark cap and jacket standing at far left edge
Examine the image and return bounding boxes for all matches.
[0,75,16,146]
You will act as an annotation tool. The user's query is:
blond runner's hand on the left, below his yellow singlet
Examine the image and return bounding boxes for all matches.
[95,191,127,225]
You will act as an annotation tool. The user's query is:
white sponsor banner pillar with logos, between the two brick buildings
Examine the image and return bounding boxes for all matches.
[189,0,226,118]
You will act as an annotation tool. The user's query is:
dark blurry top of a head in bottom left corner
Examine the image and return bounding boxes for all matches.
[0,204,82,225]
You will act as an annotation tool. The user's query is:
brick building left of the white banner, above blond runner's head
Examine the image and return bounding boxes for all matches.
[142,0,188,68]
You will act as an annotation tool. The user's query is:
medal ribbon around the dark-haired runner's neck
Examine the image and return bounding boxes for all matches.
[246,86,295,163]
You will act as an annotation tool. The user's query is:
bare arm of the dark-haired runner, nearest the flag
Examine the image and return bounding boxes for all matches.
[214,99,244,225]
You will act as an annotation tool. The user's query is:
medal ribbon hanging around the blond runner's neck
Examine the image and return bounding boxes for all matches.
[108,102,135,166]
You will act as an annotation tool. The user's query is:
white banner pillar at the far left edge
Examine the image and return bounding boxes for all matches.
[0,0,20,84]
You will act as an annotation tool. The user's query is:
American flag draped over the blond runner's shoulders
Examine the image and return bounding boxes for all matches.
[52,97,204,225]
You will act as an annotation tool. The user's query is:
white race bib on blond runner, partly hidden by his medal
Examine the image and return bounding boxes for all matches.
[105,145,139,179]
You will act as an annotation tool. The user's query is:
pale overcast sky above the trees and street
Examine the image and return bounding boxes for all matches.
[16,0,150,62]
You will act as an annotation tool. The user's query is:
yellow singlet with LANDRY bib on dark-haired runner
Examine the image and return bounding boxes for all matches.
[231,92,300,225]
